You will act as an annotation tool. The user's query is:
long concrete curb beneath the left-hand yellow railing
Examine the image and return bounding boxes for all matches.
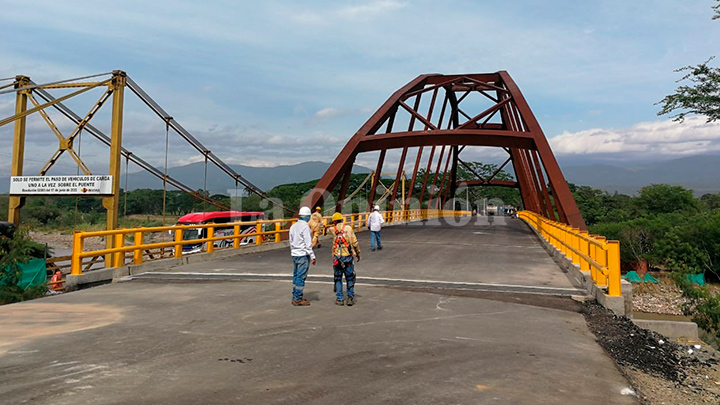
[65,219,434,291]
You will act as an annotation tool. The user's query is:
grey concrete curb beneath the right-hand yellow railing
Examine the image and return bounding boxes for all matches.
[521,218,633,318]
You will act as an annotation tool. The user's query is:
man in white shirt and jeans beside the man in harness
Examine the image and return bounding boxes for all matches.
[289,207,315,307]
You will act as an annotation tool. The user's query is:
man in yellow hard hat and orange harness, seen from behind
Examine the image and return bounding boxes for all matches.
[332,212,360,306]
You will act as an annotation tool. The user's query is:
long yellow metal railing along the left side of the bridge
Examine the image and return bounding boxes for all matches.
[70,209,470,276]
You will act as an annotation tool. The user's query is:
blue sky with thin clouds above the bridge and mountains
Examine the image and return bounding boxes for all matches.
[0,0,720,176]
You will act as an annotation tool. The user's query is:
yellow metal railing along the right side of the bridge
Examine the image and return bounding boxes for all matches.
[518,211,622,296]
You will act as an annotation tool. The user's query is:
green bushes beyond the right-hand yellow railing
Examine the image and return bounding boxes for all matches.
[573,184,720,339]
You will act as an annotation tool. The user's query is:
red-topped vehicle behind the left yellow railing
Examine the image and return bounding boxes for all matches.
[177,211,265,254]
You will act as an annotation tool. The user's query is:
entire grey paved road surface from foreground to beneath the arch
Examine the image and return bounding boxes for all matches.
[0,218,636,404]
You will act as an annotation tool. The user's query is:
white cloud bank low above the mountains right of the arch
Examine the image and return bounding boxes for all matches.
[549,117,720,156]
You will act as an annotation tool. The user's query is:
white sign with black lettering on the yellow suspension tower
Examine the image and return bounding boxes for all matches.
[10,176,112,195]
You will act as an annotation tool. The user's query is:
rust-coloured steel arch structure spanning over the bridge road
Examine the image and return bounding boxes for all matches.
[303,71,587,230]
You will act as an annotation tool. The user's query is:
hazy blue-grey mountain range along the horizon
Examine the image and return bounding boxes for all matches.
[0,155,720,196]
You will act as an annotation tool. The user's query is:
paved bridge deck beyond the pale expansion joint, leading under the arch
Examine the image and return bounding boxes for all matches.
[142,217,585,294]
